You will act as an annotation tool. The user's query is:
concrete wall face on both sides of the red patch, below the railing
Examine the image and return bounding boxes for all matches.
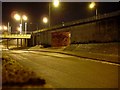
[31,16,120,45]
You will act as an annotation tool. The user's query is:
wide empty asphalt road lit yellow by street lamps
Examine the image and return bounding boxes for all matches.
[2,50,119,88]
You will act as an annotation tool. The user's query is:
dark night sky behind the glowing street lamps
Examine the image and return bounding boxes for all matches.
[2,2,120,29]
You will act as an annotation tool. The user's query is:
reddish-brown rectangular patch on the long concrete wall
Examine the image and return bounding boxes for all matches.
[51,31,71,47]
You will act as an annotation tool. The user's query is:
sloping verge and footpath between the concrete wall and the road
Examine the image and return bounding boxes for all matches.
[28,43,120,64]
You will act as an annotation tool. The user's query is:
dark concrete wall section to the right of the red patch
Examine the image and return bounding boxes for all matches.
[70,18,120,43]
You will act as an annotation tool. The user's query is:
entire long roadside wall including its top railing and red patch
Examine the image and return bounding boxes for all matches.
[29,11,120,47]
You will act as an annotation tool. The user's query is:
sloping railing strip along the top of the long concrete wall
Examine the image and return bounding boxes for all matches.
[32,10,120,33]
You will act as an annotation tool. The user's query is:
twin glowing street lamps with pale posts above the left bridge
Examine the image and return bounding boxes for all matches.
[14,14,28,34]
